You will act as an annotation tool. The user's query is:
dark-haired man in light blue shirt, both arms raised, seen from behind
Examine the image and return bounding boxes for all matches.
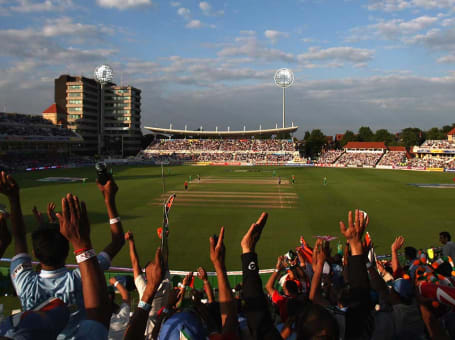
[0,172,125,339]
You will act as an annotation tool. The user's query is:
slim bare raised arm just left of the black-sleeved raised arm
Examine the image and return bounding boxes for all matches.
[210,227,239,334]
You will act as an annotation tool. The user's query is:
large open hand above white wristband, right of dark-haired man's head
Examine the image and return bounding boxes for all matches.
[57,194,91,249]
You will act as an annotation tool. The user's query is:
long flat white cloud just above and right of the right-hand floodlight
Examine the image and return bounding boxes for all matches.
[298,46,374,63]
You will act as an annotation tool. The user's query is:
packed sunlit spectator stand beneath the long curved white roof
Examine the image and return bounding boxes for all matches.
[138,139,299,164]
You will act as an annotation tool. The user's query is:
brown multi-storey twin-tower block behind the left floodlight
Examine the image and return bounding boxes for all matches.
[43,75,142,156]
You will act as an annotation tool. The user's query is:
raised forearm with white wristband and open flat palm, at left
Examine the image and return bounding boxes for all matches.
[57,194,111,328]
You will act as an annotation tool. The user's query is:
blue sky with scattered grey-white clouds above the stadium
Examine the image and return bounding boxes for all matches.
[0,0,455,136]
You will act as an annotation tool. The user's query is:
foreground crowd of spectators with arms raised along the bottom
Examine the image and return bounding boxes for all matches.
[0,172,455,340]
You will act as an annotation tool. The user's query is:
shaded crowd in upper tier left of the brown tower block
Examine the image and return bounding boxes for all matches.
[0,114,76,137]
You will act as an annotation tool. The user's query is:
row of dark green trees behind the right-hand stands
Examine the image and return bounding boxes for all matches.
[300,123,455,157]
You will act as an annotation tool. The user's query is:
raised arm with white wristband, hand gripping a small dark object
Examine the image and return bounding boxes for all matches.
[97,178,125,260]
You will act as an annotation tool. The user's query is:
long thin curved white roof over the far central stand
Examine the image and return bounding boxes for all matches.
[144,126,299,137]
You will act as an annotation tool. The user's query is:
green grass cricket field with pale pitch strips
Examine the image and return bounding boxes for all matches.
[0,166,455,270]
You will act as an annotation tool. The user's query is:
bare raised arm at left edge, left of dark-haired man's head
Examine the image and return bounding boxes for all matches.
[0,171,28,254]
